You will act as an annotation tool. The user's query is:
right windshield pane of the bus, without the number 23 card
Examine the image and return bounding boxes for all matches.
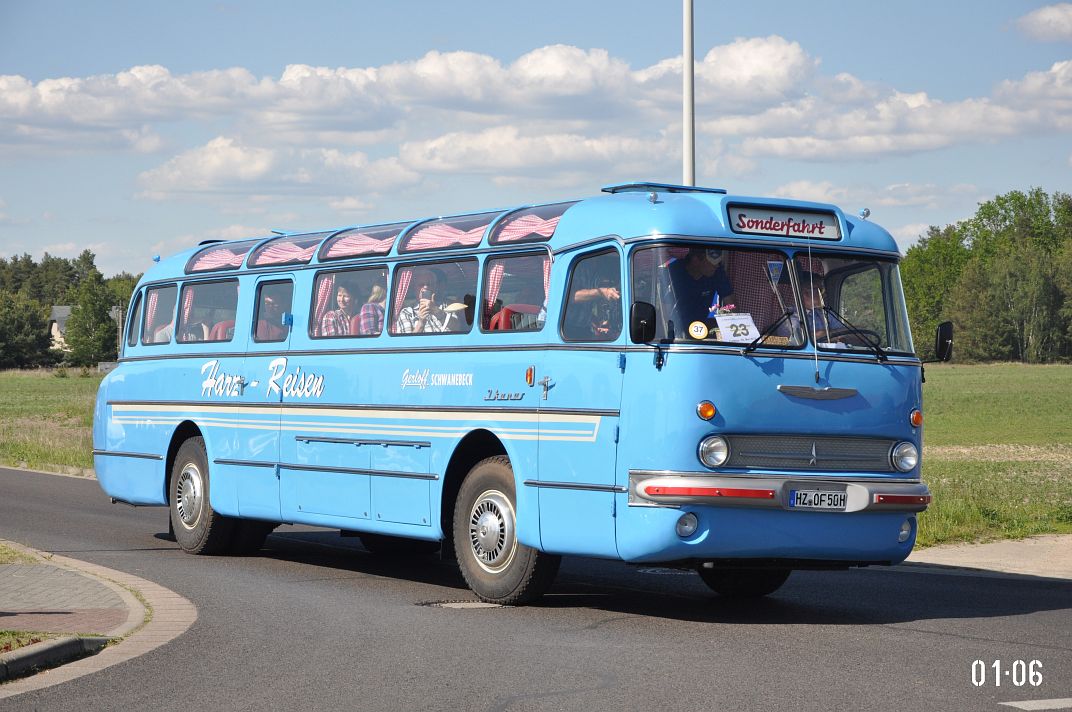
[794,253,913,354]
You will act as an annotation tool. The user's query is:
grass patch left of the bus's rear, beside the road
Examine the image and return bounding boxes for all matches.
[0,370,102,472]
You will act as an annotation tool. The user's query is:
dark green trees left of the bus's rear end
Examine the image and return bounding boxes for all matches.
[0,250,139,368]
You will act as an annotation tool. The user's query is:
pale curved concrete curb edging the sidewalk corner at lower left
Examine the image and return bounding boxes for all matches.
[0,540,197,699]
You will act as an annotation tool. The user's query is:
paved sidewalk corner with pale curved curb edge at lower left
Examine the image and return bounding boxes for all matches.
[0,542,197,699]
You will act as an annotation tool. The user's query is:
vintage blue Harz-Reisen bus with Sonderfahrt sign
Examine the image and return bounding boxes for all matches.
[93,183,952,604]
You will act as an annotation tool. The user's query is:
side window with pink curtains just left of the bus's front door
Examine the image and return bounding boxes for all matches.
[480,252,551,331]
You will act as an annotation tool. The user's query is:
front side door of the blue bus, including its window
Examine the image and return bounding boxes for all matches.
[536,248,625,557]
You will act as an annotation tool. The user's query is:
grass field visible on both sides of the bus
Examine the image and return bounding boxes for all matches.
[0,364,1072,546]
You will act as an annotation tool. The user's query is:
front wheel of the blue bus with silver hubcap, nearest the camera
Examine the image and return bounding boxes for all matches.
[453,456,561,605]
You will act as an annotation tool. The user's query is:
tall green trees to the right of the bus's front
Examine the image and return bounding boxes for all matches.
[900,188,1072,364]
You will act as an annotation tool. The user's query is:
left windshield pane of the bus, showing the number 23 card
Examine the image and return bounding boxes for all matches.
[632,244,805,348]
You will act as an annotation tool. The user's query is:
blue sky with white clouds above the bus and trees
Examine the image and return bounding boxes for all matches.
[0,0,1072,276]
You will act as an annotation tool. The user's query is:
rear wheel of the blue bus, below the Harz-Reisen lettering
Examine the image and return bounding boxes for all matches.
[168,437,235,554]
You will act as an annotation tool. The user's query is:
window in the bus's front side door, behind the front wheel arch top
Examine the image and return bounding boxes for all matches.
[562,250,622,341]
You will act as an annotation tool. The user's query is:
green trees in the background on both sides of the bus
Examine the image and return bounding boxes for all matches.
[0,188,1072,368]
